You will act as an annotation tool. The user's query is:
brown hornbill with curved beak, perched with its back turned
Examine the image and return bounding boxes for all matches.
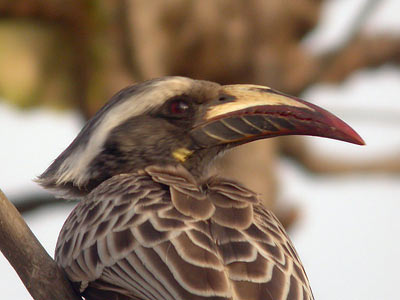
[37,76,364,300]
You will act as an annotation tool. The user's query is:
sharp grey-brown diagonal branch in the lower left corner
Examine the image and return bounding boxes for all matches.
[0,190,81,300]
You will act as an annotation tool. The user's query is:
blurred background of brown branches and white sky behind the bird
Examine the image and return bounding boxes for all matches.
[0,0,400,300]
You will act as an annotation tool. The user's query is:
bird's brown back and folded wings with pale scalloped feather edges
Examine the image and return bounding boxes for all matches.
[56,167,313,300]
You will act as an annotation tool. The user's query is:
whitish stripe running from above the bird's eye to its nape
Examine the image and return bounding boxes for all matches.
[56,77,193,186]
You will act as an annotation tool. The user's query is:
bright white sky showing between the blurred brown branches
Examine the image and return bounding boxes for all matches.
[0,0,400,300]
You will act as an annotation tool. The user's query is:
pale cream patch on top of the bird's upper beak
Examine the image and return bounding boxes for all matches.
[205,84,314,120]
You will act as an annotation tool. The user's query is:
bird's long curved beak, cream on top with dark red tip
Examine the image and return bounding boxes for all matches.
[191,84,365,147]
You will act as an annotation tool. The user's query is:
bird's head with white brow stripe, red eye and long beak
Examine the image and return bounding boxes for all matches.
[38,77,364,198]
